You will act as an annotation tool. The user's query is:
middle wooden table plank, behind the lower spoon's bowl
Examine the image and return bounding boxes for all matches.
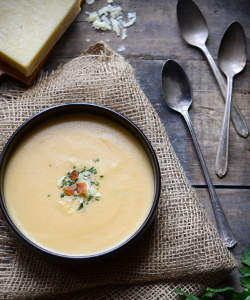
[131,60,250,186]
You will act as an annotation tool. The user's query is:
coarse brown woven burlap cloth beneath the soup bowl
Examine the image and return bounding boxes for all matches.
[0,44,236,300]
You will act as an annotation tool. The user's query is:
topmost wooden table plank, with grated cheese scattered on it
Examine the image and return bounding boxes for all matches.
[52,0,250,60]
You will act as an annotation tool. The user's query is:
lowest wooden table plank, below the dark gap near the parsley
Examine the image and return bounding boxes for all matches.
[195,188,250,292]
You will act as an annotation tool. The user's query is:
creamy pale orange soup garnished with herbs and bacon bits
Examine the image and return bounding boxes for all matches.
[4,115,154,256]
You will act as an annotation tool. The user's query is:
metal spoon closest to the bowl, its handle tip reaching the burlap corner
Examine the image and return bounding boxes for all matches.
[161,59,236,248]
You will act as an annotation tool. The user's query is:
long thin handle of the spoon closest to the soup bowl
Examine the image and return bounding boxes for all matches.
[181,111,237,248]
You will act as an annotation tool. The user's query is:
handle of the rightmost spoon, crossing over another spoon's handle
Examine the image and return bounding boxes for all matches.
[215,77,233,177]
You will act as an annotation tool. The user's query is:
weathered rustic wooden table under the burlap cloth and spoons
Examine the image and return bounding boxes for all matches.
[0,0,250,291]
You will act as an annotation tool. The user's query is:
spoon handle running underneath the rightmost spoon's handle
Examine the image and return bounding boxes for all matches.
[201,45,249,138]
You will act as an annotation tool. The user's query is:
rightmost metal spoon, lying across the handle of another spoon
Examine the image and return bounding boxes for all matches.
[215,22,247,177]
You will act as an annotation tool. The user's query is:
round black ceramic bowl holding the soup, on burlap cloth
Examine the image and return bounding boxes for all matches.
[0,103,161,263]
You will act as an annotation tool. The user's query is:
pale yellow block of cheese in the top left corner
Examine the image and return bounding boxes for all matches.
[0,0,81,76]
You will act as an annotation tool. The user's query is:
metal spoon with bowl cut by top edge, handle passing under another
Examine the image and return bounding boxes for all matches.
[177,0,249,137]
